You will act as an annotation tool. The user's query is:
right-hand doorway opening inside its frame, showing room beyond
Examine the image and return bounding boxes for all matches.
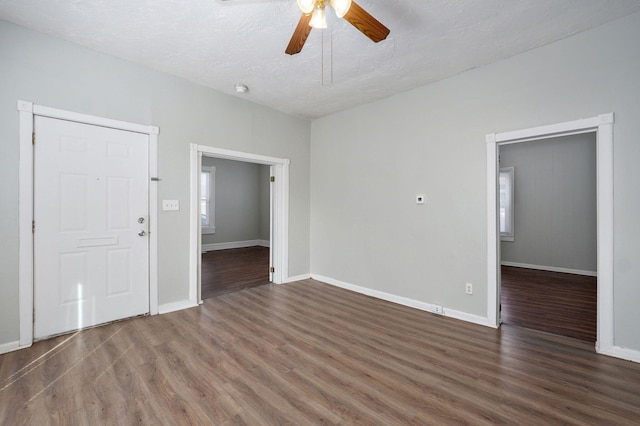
[499,132,597,343]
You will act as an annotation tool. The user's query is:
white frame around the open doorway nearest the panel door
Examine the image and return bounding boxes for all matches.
[189,144,290,304]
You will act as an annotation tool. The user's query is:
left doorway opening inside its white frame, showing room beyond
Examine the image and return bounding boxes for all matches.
[200,155,272,300]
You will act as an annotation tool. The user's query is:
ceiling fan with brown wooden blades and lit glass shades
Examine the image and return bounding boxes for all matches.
[285,0,390,55]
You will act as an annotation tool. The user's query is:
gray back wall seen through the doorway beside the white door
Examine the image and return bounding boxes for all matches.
[202,157,269,244]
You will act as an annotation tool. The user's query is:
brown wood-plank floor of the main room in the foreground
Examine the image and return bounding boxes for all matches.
[0,280,640,425]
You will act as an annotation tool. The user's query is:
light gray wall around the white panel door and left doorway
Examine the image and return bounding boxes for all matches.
[0,21,310,344]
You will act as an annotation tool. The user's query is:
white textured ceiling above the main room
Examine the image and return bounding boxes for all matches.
[0,0,640,118]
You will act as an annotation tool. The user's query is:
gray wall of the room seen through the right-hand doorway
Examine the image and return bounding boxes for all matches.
[500,133,597,271]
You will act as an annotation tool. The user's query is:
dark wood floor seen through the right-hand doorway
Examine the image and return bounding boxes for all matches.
[501,266,598,342]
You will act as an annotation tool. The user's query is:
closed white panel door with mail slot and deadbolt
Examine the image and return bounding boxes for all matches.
[34,116,149,338]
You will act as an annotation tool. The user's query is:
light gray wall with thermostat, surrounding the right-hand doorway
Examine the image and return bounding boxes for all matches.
[311,14,640,350]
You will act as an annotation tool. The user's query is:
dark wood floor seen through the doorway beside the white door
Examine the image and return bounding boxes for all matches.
[201,246,269,299]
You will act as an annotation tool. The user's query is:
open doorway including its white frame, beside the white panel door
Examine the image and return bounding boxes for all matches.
[188,144,289,305]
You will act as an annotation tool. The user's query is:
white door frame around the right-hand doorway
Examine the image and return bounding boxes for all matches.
[486,113,614,354]
